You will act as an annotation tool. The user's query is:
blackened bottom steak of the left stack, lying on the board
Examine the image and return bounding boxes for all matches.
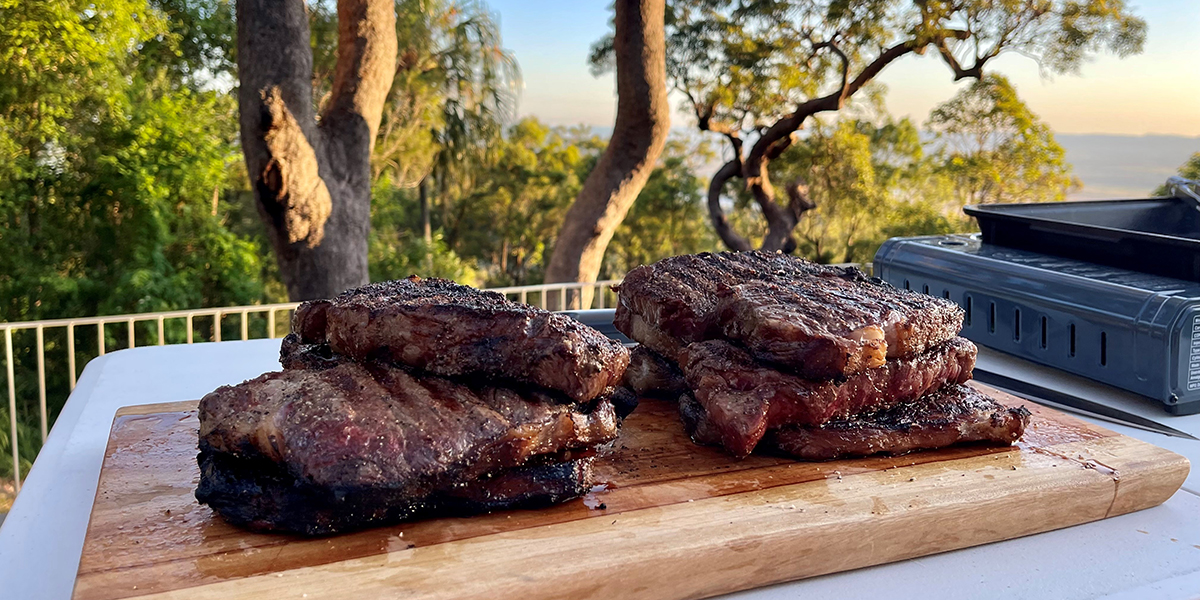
[196,449,593,535]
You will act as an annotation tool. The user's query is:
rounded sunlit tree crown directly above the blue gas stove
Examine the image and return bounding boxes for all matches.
[926,74,1080,204]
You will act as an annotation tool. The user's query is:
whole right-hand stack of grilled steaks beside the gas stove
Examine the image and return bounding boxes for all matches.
[616,252,1028,458]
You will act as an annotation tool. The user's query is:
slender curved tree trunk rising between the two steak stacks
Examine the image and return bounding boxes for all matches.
[546,0,671,307]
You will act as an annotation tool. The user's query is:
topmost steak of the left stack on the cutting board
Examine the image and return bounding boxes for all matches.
[293,276,629,402]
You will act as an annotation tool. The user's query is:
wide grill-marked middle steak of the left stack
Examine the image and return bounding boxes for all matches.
[199,362,617,502]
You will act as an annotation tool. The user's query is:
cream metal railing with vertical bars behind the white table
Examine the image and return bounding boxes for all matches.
[0,280,620,492]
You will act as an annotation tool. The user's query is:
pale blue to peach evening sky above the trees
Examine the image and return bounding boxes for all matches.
[488,0,1200,137]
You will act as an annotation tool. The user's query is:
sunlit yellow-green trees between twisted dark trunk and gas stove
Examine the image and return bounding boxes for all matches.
[758,76,1078,263]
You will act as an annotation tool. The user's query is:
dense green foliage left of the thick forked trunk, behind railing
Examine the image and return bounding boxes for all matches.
[0,0,266,475]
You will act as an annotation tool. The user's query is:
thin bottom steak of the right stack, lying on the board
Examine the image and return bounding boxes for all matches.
[679,385,1030,461]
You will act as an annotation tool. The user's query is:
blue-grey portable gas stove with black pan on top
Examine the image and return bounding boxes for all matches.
[875,178,1200,414]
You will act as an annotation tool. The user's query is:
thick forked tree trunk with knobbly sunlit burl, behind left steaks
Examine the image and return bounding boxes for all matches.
[238,0,396,300]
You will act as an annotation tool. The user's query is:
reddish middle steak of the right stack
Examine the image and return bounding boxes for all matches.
[680,337,976,456]
